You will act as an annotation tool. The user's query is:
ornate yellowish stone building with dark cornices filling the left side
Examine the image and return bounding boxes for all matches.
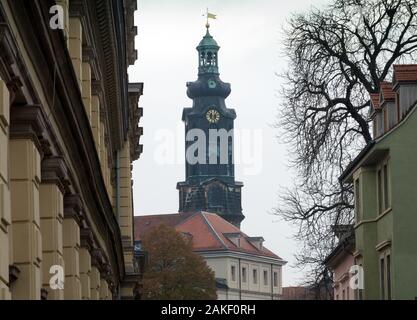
[0,0,143,300]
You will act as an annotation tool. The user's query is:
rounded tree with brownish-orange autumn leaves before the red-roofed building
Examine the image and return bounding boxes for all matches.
[141,225,217,300]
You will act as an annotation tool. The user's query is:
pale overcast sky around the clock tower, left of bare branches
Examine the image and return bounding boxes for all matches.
[129,0,327,286]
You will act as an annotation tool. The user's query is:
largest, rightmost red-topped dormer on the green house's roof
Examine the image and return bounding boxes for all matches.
[393,64,417,121]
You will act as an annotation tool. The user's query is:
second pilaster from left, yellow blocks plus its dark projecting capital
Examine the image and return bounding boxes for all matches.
[9,105,47,300]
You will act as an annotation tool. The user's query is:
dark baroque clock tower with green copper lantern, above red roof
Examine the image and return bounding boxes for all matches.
[177,24,244,227]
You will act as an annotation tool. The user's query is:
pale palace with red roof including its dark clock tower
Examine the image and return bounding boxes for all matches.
[135,24,286,300]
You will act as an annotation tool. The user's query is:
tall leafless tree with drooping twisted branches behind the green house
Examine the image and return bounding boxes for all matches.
[276,0,417,280]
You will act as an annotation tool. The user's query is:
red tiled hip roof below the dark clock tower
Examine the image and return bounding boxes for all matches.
[135,212,281,259]
